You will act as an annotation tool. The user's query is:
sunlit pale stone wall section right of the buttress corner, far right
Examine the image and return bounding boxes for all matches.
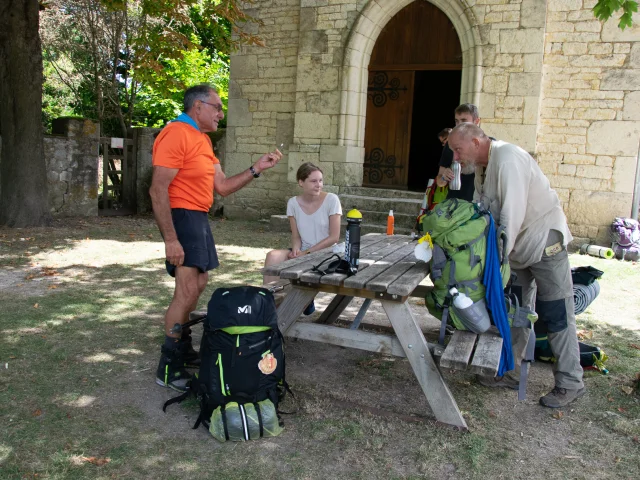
[537,0,640,244]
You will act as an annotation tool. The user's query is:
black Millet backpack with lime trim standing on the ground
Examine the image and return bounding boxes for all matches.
[164,286,288,442]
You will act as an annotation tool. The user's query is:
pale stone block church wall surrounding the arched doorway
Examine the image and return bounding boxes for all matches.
[225,0,640,242]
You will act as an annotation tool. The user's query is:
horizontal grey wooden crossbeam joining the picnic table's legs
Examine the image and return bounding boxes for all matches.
[287,322,406,357]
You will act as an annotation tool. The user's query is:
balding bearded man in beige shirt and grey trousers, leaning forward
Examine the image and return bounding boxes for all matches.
[449,123,586,408]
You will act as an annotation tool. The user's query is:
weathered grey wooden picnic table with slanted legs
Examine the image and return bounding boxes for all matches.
[263,234,475,429]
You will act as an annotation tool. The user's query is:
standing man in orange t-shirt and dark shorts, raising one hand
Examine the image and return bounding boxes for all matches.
[149,84,282,391]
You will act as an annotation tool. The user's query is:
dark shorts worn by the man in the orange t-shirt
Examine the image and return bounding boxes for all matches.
[165,208,220,277]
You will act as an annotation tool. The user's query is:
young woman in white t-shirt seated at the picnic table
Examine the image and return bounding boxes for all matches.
[264,162,342,314]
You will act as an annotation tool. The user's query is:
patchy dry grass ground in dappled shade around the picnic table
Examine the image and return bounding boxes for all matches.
[0,217,640,480]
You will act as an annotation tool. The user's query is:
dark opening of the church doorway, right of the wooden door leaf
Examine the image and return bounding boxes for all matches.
[408,70,462,191]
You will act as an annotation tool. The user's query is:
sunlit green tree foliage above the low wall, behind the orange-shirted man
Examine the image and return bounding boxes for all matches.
[41,0,260,136]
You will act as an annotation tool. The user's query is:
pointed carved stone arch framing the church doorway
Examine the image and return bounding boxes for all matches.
[338,0,482,151]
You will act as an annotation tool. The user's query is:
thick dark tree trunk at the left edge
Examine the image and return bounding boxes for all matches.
[0,0,51,227]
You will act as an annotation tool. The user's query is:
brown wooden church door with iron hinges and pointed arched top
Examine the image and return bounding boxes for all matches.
[362,1,462,189]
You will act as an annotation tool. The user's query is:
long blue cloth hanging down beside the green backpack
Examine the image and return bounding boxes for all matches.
[482,214,514,376]
